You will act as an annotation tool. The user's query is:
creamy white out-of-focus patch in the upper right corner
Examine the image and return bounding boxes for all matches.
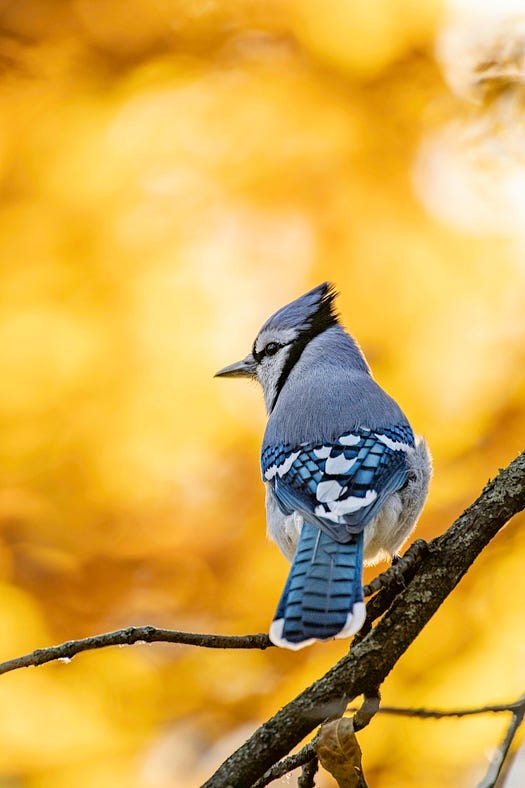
[414,7,525,238]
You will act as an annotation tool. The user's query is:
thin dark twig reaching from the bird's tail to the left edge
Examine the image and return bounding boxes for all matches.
[0,626,273,675]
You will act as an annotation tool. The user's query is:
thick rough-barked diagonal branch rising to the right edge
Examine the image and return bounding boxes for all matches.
[204,452,525,788]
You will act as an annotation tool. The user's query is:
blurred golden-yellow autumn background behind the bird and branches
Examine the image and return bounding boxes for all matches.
[0,0,525,788]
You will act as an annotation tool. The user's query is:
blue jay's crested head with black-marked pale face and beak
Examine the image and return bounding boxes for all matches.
[215,282,338,412]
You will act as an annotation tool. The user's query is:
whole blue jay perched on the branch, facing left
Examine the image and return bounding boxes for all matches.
[215,282,432,650]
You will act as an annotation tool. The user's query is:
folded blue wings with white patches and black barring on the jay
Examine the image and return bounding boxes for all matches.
[261,425,414,542]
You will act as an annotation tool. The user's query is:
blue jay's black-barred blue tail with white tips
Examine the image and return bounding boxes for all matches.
[270,522,365,649]
